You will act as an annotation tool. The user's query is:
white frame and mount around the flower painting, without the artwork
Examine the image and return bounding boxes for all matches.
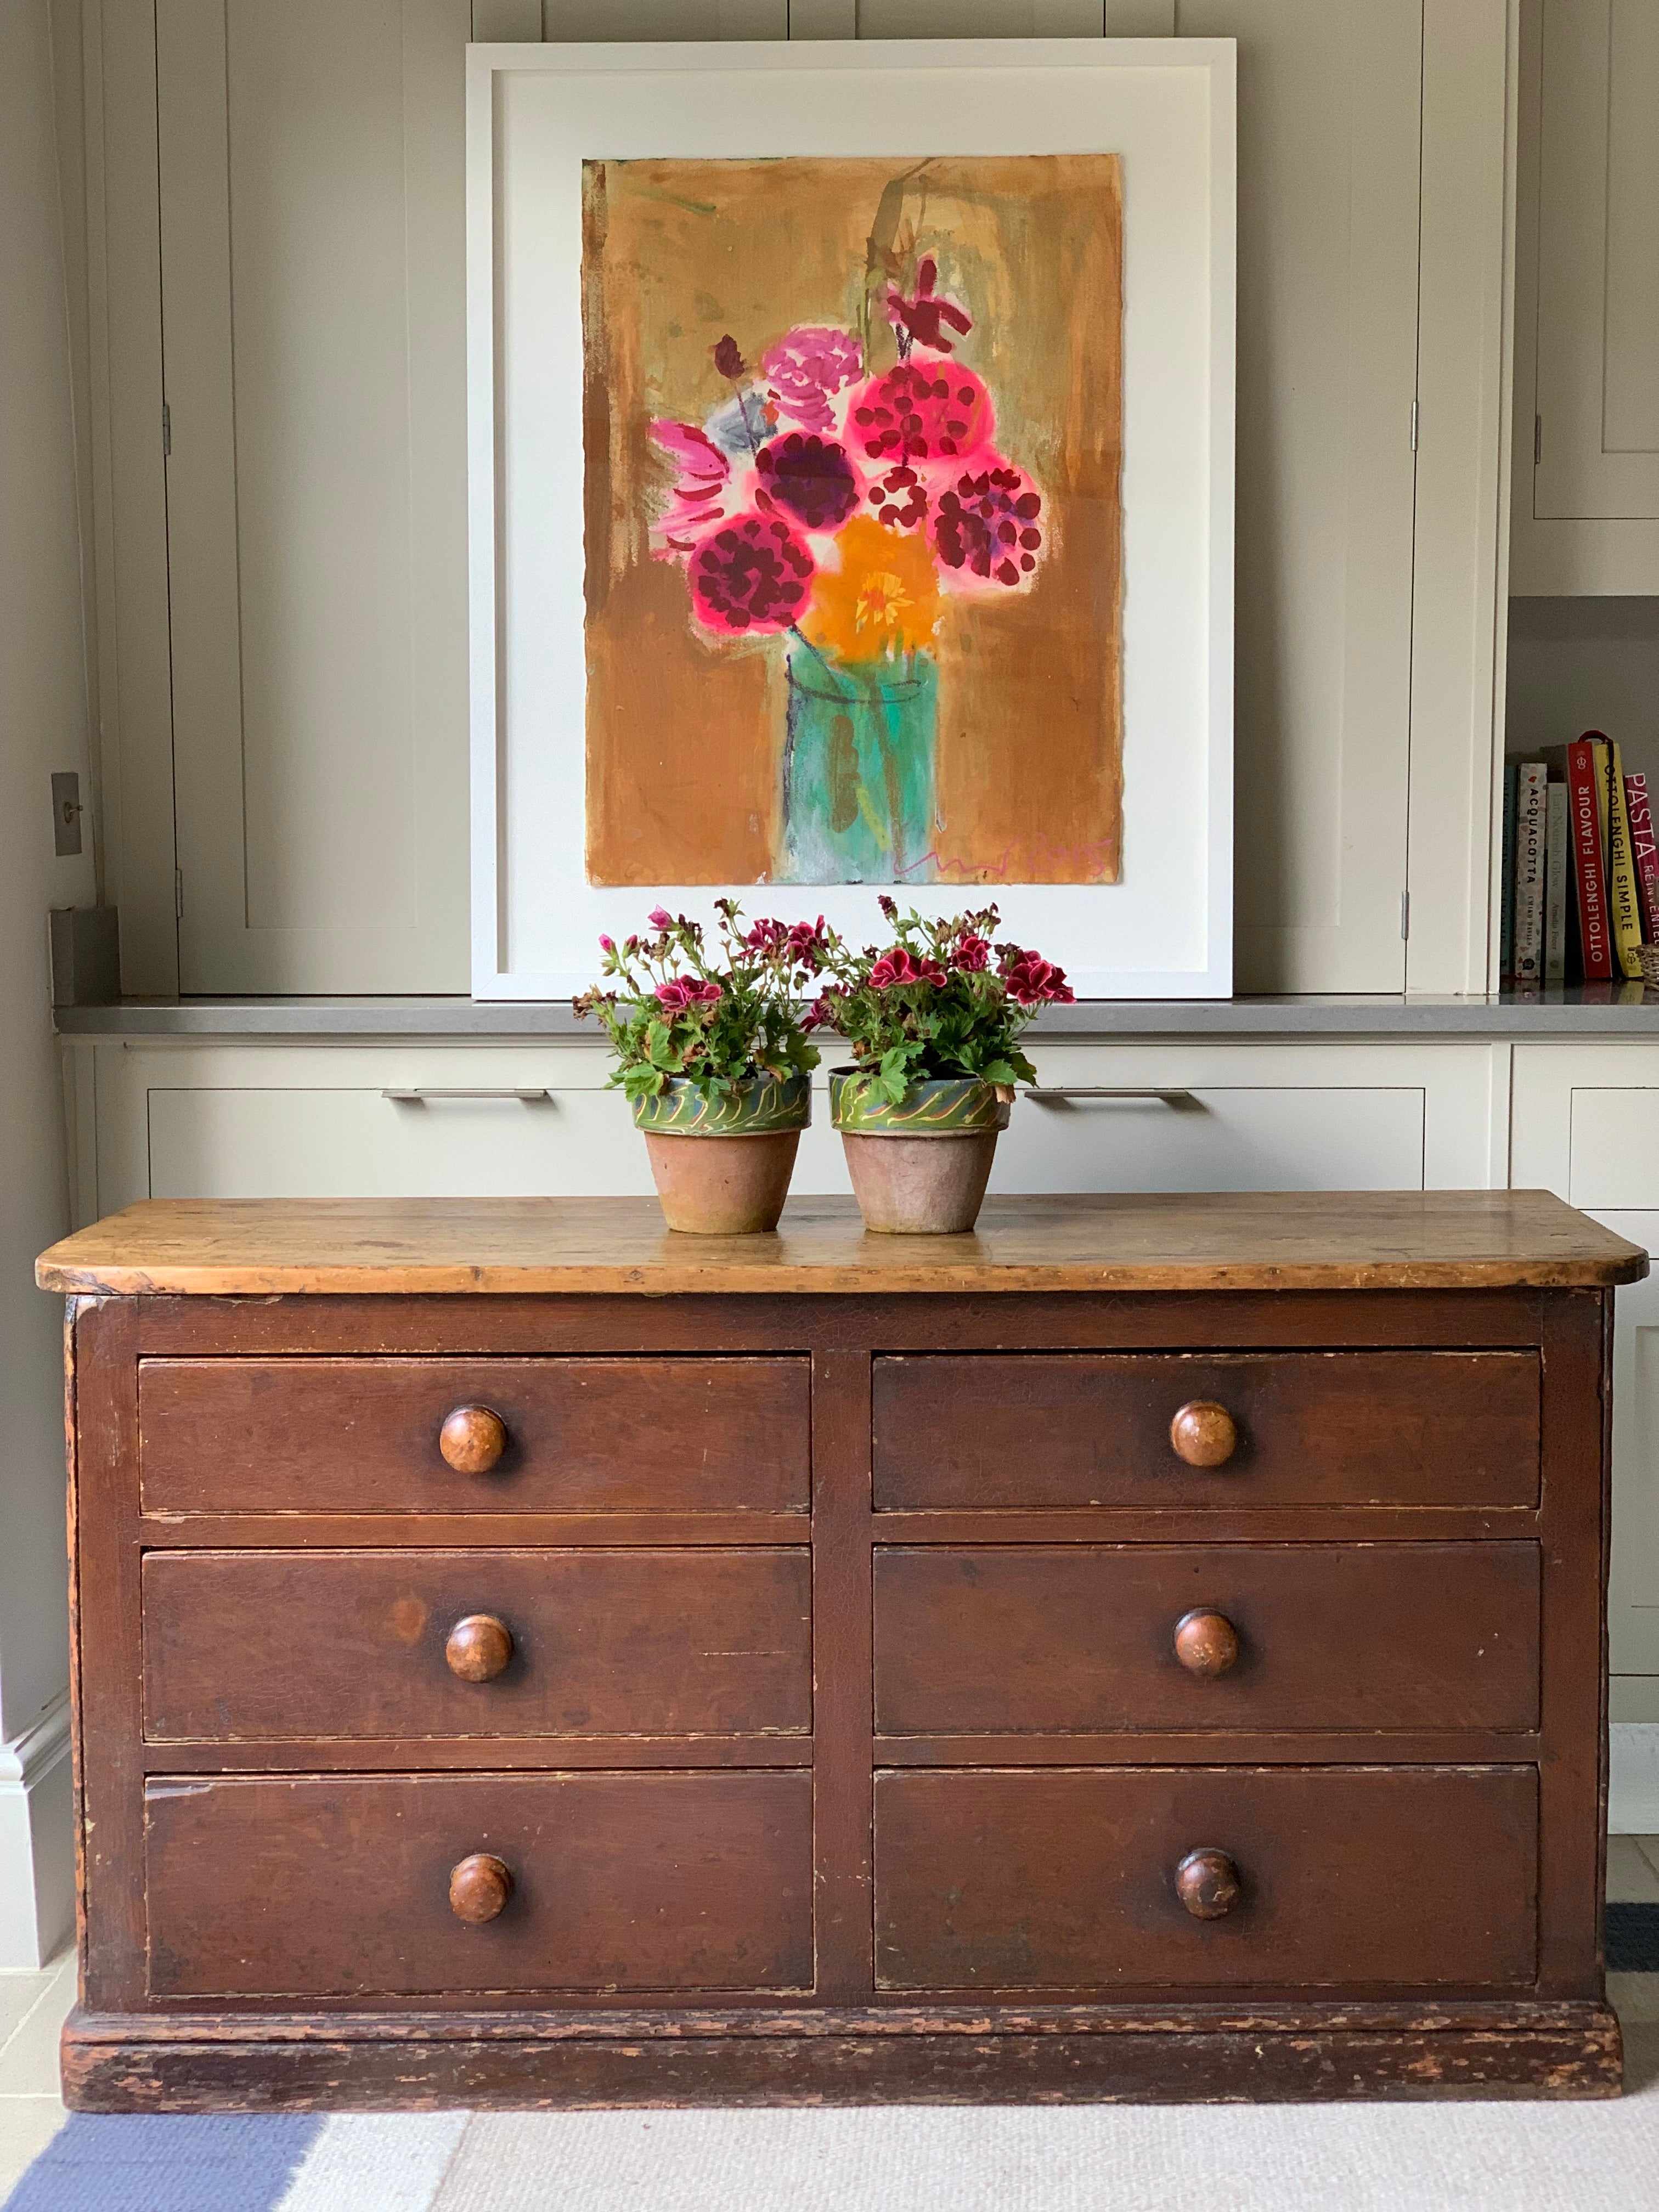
[467,38,1237,1000]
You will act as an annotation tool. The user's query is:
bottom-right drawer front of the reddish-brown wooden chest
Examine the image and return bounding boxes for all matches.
[876,1768,1537,1993]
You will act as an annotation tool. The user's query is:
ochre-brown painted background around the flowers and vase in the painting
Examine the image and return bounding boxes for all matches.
[582,155,1124,885]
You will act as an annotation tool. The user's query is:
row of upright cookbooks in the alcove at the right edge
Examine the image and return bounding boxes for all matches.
[1500,730,1659,989]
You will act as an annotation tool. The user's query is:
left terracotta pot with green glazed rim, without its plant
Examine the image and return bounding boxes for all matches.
[633,1075,812,1237]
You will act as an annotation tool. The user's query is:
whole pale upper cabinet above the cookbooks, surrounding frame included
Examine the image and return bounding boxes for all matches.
[1511,0,1659,595]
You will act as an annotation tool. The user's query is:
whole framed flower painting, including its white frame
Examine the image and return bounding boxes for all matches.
[467,40,1234,997]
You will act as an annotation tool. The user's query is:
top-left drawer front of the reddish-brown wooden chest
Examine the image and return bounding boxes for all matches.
[139,1358,812,1513]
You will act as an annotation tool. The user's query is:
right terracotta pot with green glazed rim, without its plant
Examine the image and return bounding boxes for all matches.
[830,1068,1011,1237]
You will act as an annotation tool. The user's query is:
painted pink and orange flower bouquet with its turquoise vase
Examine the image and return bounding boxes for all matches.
[650,248,1044,883]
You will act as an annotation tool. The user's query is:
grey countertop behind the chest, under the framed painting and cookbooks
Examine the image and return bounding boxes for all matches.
[58,982,1659,1046]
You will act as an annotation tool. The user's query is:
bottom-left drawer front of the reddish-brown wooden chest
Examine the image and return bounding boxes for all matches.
[144,1772,812,1997]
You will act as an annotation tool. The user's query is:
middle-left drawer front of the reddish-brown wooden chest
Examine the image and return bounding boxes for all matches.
[144,1548,812,1743]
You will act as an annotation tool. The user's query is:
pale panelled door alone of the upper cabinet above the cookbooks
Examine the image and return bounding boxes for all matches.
[1533,0,1659,531]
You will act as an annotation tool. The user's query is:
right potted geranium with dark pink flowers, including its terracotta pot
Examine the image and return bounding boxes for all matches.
[812,898,1073,1232]
